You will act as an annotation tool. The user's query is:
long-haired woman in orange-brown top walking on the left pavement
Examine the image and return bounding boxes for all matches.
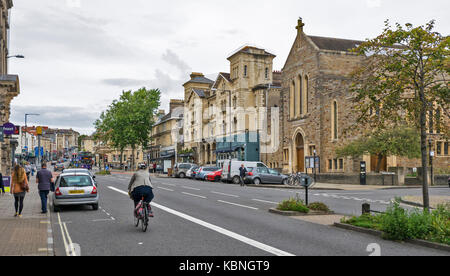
[11,165,30,217]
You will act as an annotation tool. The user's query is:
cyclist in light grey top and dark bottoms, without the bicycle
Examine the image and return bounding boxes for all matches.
[128,164,155,217]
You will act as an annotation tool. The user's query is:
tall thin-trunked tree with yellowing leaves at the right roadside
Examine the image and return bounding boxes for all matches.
[352,20,450,209]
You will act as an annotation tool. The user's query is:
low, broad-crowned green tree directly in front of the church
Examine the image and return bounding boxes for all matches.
[336,127,420,172]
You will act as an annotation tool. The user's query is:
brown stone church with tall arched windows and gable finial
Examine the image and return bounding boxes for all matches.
[282,19,450,174]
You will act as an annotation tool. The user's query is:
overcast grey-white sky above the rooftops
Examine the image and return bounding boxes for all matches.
[9,0,450,134]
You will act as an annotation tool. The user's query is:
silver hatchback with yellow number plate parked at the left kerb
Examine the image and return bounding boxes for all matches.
[52,172,99,212]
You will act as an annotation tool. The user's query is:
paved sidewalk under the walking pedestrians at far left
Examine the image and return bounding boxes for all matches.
[0,176,53,256]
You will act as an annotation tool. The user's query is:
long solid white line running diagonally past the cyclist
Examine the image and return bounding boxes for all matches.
[108,186,294,256]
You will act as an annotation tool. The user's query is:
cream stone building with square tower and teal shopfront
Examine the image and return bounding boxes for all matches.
[183,46,282,168]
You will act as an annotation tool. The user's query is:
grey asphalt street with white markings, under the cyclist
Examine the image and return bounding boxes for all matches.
[51,174,450,256]
